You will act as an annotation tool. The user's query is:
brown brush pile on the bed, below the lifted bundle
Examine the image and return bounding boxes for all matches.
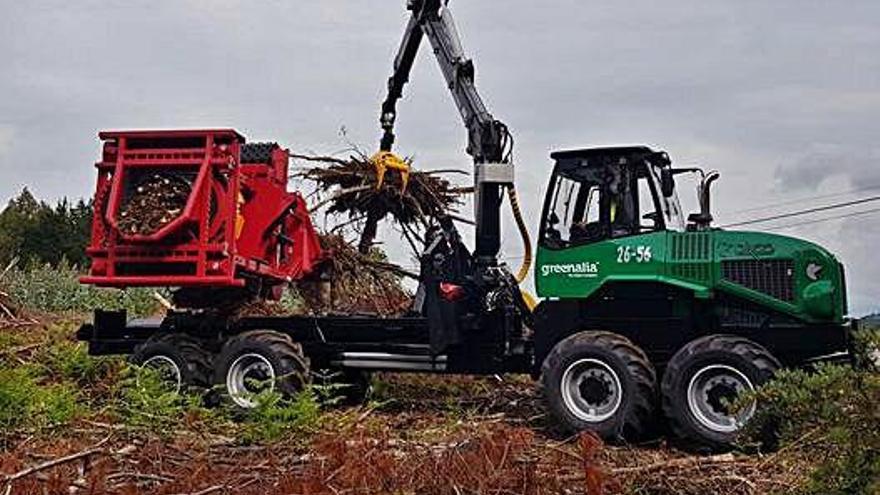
[297,234,412,316]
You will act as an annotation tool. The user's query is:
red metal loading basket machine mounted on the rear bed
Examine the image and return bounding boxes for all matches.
[81,129,321,294]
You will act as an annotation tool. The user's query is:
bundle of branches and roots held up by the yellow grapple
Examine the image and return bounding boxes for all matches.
[291,154,469,254]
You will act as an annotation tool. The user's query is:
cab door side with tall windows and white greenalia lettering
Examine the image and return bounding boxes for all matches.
[535,160,667,298]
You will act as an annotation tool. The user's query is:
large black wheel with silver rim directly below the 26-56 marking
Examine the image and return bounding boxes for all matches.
[541,332,657,442]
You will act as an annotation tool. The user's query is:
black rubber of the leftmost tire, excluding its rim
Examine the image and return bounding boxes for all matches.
[131,333,213,389]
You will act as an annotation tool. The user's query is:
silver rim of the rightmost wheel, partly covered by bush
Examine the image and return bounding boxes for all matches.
[687,364,755,433]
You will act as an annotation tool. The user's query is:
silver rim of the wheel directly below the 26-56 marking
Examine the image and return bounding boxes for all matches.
[561,359,623,423]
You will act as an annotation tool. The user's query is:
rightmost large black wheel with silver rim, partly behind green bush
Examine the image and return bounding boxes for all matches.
[660,335,781,451]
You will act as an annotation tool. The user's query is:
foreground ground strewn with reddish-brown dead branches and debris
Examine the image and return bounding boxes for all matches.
[0,364,806,495]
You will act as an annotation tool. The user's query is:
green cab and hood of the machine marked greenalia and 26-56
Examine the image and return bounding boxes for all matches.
[535,147,846,323]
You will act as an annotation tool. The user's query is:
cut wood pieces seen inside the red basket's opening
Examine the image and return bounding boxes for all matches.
[119,174,192,235]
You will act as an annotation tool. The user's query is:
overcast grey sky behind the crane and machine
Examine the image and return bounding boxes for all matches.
[0,0,880,314]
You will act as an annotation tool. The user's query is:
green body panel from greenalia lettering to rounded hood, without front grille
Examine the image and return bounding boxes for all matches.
[535,230,847,323]
